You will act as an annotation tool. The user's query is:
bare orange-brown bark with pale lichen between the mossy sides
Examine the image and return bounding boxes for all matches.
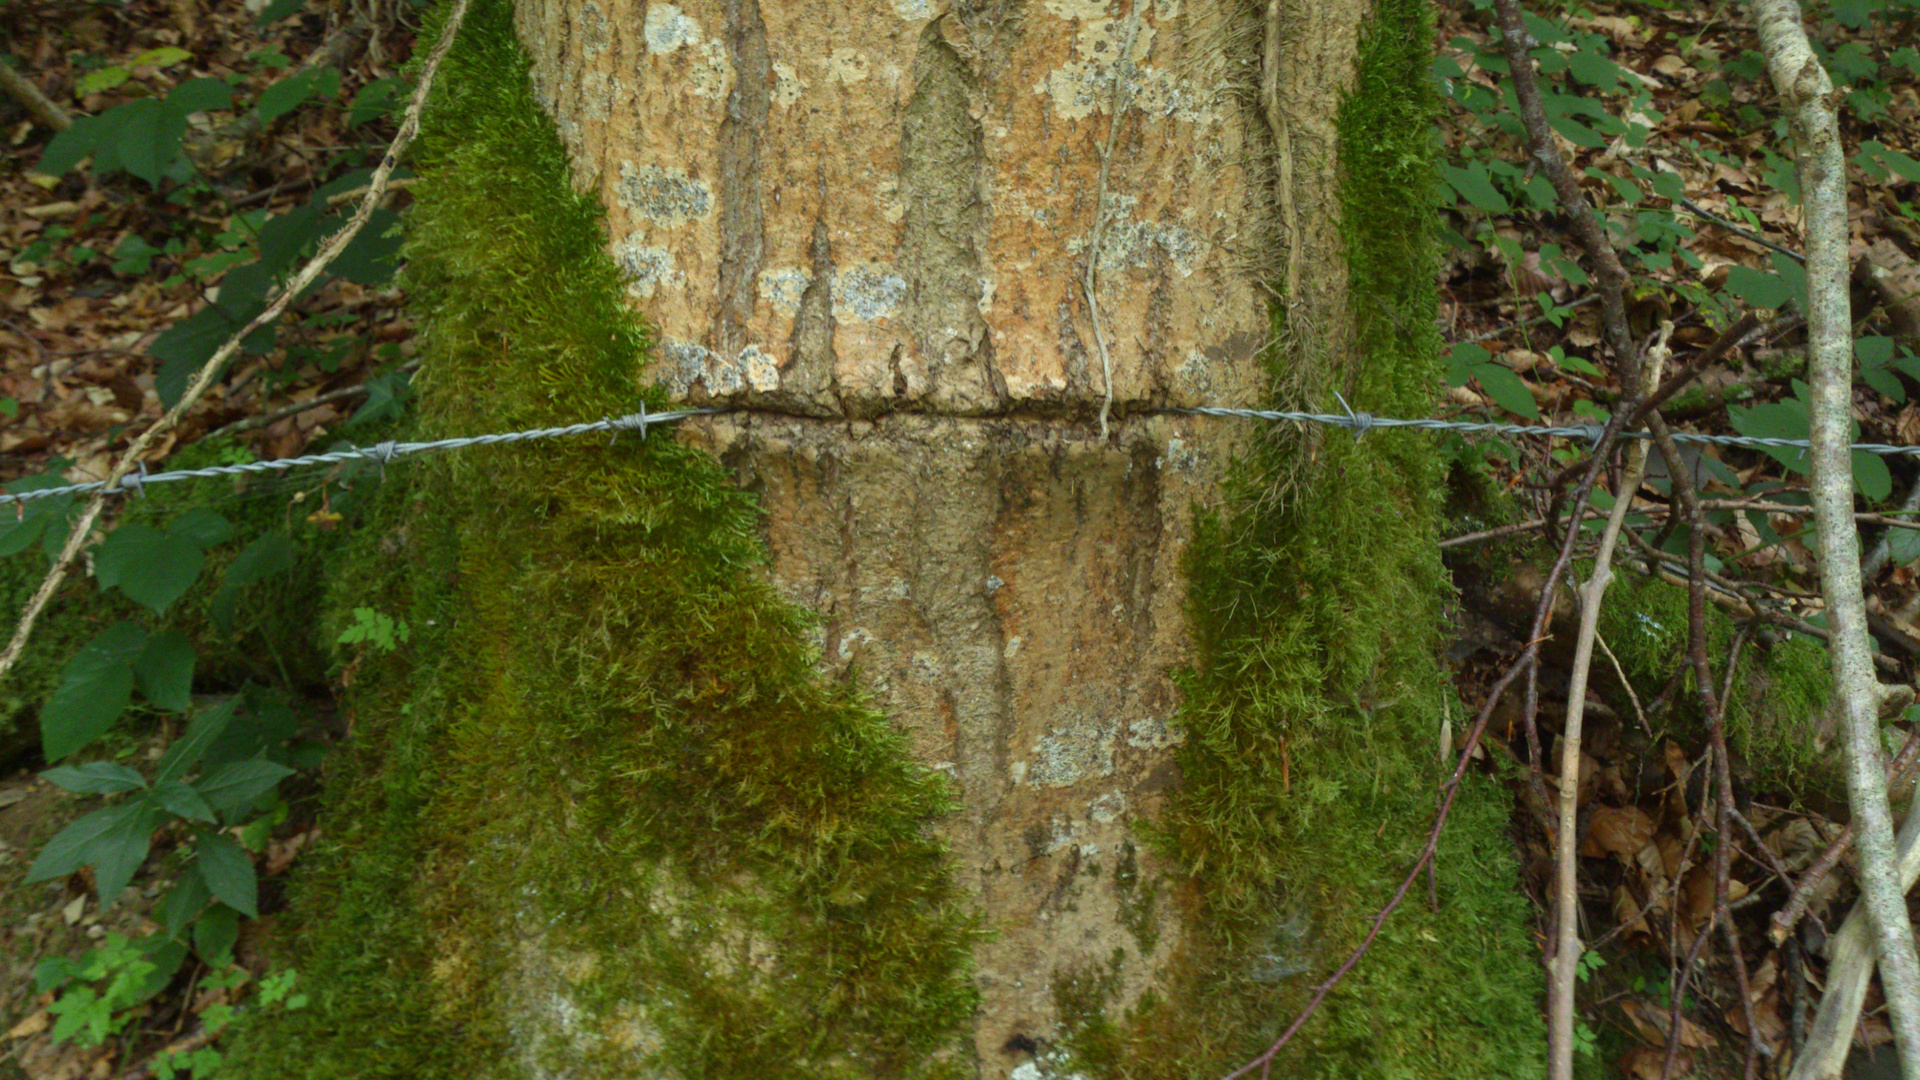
[516,0,1363,1076]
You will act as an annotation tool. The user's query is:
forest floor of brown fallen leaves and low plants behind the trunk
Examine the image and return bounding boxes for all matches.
[0,0,1920,1080]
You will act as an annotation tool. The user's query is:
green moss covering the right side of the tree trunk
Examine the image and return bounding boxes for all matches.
[1056,0,1544,1080]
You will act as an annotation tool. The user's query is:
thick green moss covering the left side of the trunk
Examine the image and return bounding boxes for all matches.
[234,0,979,1078]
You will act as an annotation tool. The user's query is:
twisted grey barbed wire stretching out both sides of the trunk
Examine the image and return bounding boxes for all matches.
[0,394,1920,505]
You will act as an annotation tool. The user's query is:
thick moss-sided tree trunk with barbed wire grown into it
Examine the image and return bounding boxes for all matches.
[240,0,1538,1080]
